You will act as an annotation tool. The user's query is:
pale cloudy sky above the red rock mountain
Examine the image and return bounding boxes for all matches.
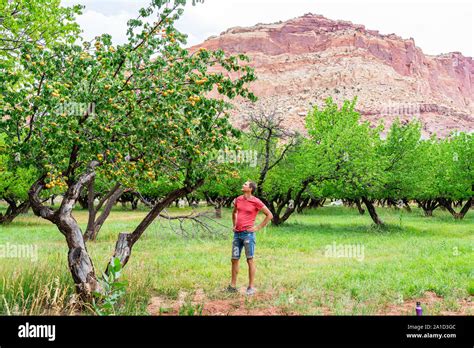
[62,0,474,57]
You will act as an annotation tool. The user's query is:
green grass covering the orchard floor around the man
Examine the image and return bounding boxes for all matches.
[0,207,474,315]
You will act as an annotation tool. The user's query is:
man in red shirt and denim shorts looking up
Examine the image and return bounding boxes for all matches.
[227,181,273,295]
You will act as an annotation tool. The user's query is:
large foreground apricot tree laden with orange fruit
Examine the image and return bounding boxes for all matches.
[0,0,255,298]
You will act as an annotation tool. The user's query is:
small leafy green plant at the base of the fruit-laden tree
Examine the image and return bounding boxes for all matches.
[92,257,127,316]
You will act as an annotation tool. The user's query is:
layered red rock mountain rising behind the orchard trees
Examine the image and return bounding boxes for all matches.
[190,14,474,136]
